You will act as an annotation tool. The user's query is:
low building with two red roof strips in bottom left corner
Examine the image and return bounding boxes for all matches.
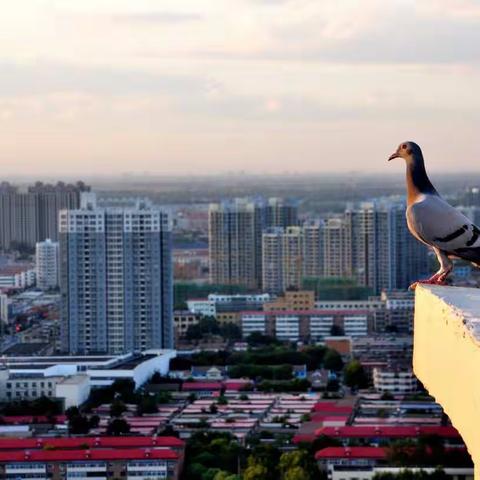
[0,437,184,480]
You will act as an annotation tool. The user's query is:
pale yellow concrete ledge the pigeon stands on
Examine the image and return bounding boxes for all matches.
[413,285,480,474]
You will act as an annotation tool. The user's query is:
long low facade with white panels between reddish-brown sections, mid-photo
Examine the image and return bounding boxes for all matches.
[241,310,372,342]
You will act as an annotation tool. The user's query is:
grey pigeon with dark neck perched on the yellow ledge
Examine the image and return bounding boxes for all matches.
[388,142,480,289]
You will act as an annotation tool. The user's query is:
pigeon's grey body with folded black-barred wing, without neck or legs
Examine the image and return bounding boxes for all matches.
[407,195,480,263]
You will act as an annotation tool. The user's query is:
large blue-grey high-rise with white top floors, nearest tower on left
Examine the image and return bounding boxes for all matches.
[59,195,173,354]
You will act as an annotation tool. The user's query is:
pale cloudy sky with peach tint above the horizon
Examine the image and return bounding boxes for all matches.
[0,0,480,177]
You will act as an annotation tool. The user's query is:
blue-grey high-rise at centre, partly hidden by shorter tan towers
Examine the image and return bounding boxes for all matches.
[208,198,298,288]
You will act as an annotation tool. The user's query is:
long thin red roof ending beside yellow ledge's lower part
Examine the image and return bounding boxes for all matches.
[315,426,460,438]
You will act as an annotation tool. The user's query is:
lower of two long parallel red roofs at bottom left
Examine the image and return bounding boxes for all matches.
[0,448,178,463]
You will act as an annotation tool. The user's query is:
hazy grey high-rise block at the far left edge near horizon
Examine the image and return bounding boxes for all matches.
[0,182,90,249]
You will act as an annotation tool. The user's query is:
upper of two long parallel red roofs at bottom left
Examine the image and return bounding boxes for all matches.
[0,437,185,452]
